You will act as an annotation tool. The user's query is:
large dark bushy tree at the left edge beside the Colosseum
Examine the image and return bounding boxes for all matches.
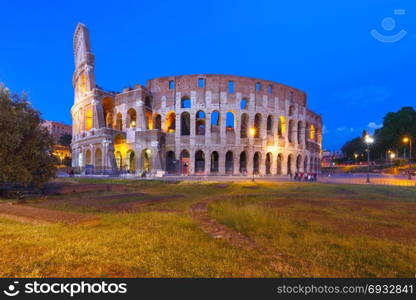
[0,84,55,187]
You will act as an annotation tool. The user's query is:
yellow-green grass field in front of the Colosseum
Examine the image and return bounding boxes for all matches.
[0,179,416,277]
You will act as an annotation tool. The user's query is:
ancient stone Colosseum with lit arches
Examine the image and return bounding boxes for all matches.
[71,24,322,176]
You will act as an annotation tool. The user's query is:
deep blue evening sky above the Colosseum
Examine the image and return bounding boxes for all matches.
[0,0,416,149]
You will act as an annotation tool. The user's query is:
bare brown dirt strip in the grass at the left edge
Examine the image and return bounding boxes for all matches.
[0,203,99,224]
